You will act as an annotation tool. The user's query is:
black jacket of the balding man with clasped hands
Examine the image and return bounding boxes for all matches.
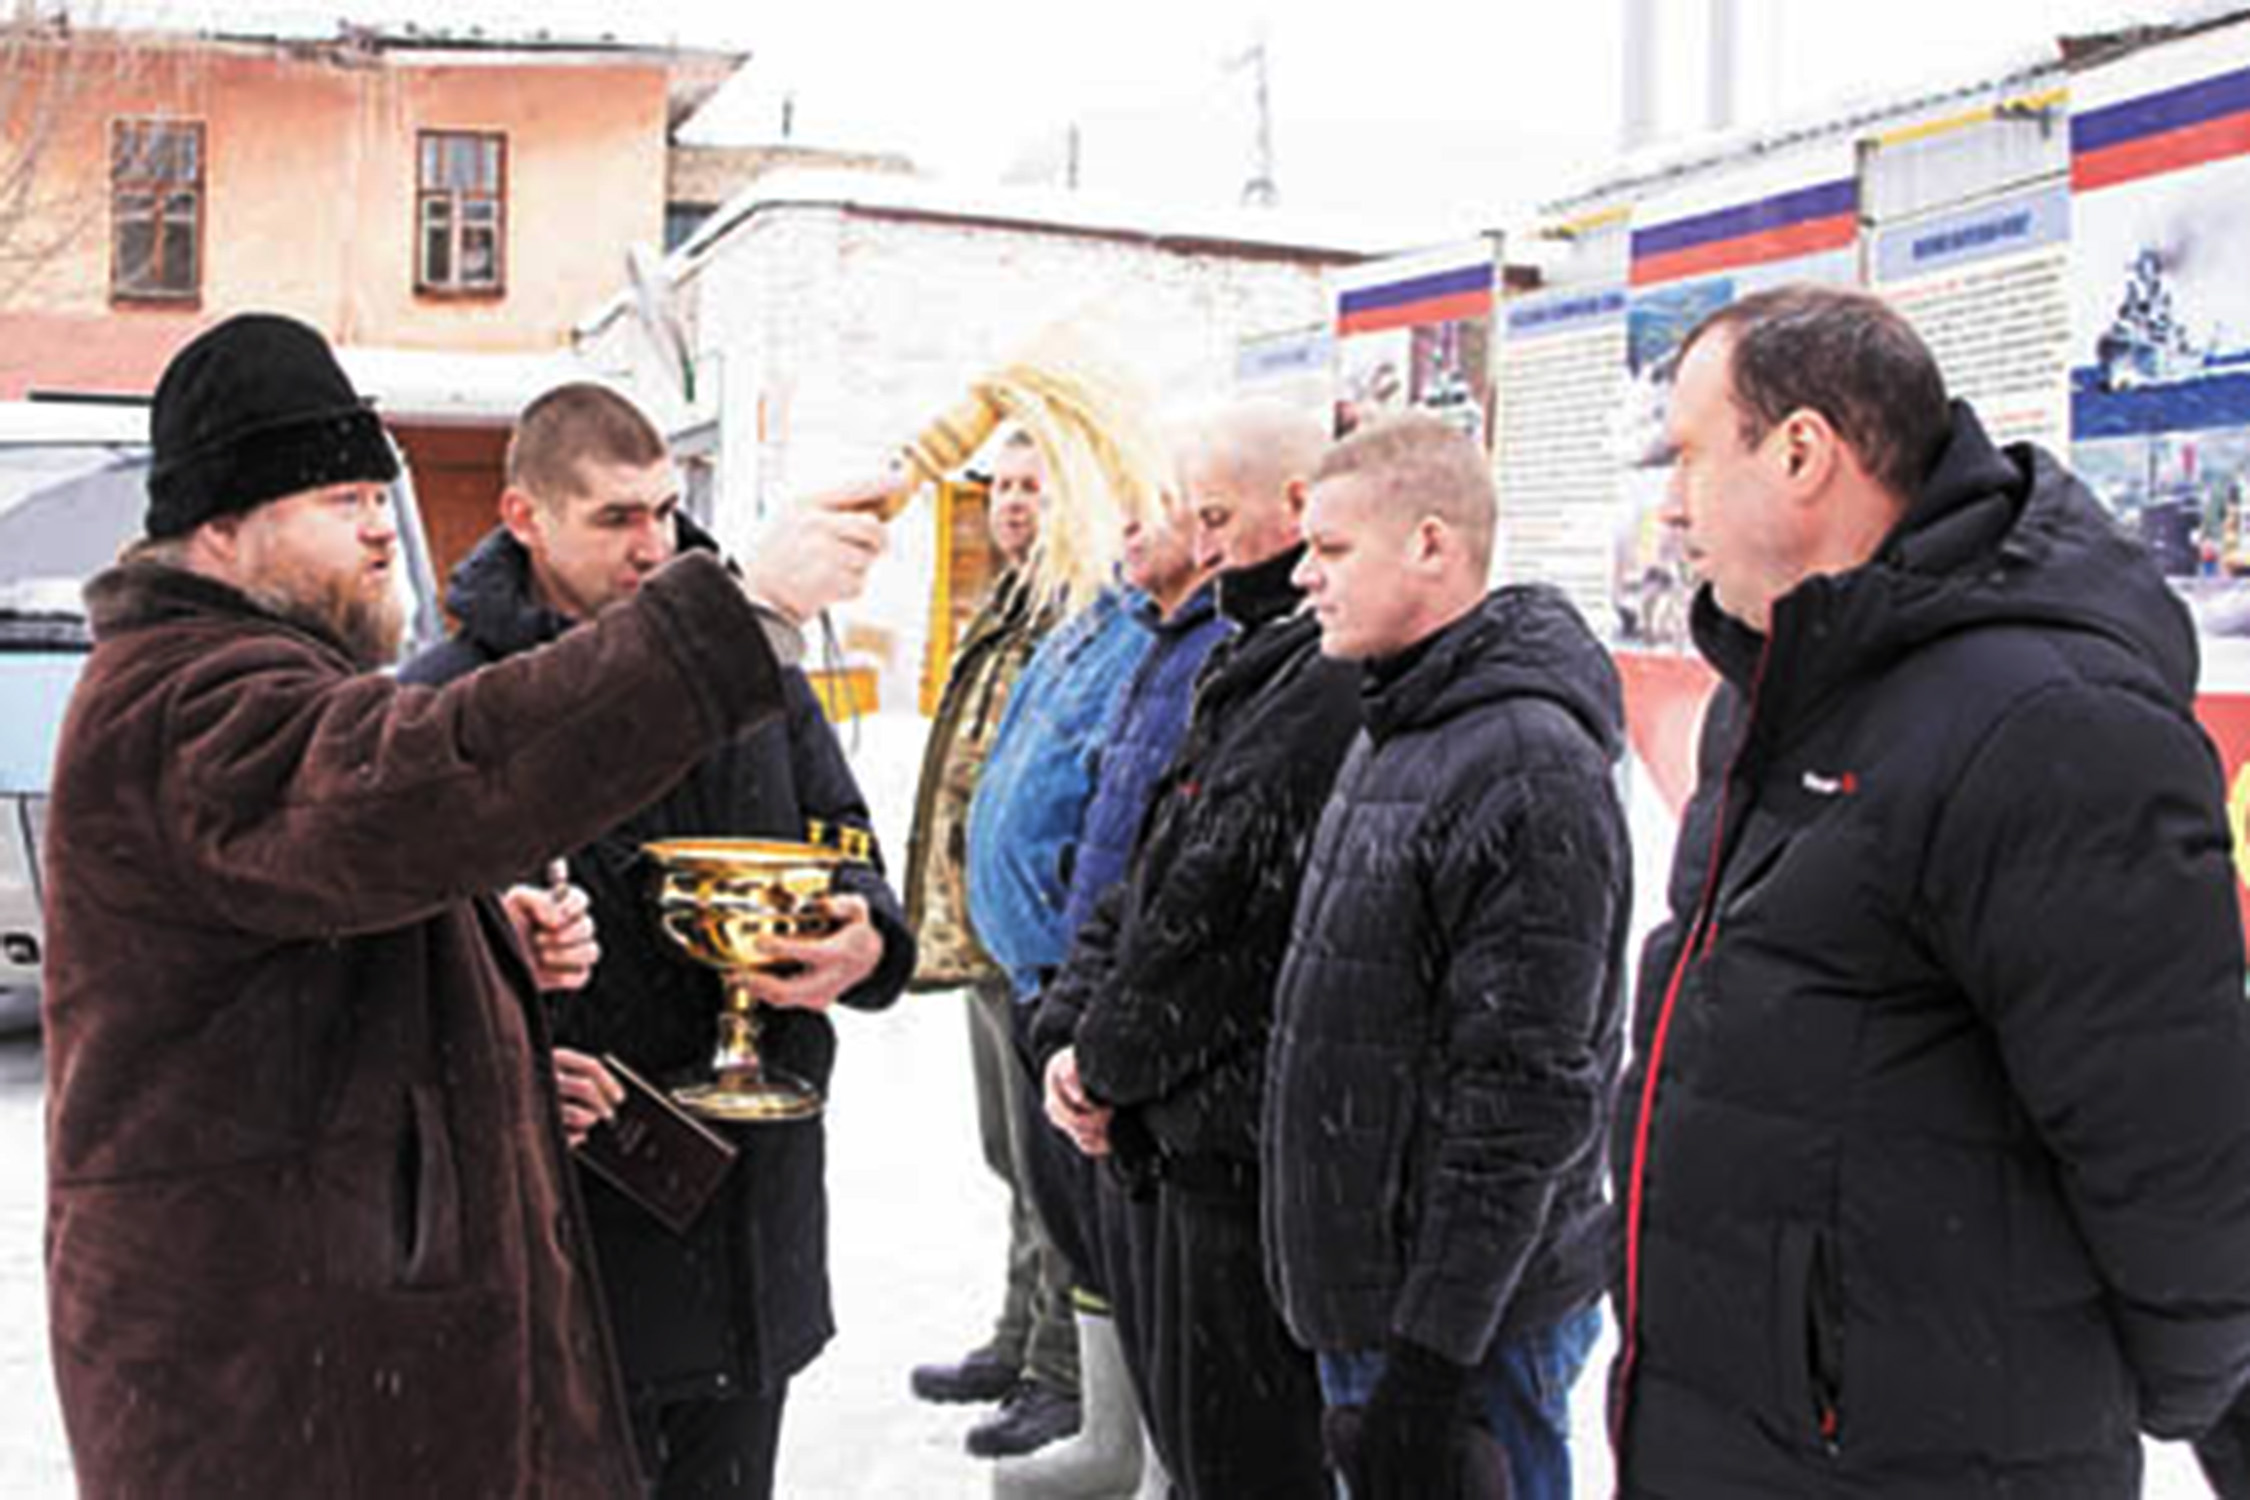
[1033,549,1359,1185]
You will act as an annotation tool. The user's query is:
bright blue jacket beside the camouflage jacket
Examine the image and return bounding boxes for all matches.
[968,589,1150,994]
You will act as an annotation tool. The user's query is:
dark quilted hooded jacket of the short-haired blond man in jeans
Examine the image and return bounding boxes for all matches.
[1262,587,1631,1365]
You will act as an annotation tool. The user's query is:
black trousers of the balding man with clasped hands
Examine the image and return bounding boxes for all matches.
[1134,1163,1334,1500]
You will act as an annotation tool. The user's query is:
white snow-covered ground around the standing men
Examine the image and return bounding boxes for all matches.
[0,715,2207,1500]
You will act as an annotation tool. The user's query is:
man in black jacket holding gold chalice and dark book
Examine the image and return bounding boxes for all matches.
[407,385,914,1500]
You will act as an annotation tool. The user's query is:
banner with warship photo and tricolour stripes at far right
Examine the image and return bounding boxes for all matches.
[2070,57,2250,636]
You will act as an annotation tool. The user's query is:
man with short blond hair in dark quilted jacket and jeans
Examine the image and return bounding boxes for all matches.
[1262,414,1631,1500]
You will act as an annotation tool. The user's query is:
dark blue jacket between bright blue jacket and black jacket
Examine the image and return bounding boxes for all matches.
[1062,582,1233,933]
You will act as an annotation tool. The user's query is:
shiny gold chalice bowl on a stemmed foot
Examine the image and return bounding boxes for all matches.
[646,839,848,1122]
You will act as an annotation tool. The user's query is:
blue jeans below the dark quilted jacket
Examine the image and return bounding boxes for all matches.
[1321,1302,1602,1500]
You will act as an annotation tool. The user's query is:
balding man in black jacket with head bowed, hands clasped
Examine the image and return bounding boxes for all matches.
[1035,405,1359,1500]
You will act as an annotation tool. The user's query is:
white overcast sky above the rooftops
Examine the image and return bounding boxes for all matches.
[149,0,2212,229]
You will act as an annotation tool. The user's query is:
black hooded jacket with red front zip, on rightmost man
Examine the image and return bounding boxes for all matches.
[1616,407,2250,1500]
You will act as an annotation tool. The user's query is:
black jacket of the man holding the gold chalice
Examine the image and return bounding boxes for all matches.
[401,522,914,1401]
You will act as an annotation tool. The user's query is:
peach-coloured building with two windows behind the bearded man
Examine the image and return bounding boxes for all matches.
[0,22,743,584]
